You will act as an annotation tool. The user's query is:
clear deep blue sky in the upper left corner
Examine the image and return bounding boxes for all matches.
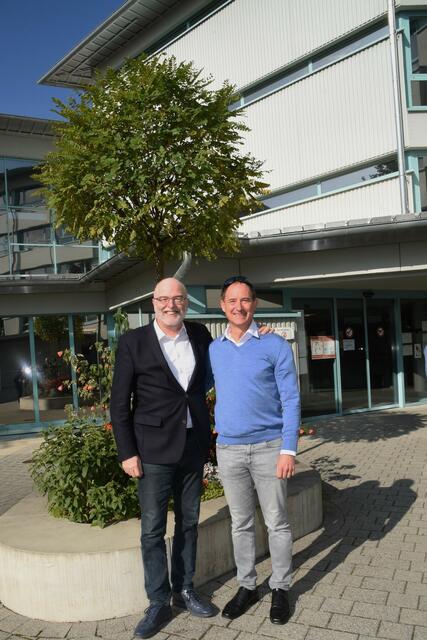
[0,0,124,118]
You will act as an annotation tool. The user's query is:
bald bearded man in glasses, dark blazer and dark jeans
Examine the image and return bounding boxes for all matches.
[111,278,216,638]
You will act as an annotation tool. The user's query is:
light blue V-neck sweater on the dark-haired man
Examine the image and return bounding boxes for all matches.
[209,333,300,451]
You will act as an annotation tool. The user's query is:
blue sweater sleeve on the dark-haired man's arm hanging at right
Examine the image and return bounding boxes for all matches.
[274,340,301,452]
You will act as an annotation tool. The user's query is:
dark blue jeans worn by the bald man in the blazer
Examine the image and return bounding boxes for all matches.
[138,429,204,603]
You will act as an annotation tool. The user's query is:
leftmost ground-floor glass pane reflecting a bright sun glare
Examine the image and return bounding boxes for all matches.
[0,317,34,434]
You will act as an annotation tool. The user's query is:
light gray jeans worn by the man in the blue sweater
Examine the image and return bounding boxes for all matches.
[217,439,292,590]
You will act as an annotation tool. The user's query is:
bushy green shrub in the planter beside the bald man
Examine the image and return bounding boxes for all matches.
[30,413,139,527]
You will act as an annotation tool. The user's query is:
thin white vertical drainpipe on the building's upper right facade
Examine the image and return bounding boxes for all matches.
[388,0,409,214]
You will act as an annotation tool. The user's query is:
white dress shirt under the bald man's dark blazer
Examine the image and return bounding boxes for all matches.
[153,320,196,429]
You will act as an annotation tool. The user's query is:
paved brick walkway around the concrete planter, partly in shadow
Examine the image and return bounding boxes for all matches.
[0,407,427,640]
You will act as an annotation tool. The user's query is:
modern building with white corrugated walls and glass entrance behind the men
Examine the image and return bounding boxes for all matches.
[0,0,427,432]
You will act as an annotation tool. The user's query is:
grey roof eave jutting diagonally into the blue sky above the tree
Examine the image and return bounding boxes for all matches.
[39,0,187,87]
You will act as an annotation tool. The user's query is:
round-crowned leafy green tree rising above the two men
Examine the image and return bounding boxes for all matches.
[37,56,267,279]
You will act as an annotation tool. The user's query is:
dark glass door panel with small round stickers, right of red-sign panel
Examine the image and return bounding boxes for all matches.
[337,300,369,411]
